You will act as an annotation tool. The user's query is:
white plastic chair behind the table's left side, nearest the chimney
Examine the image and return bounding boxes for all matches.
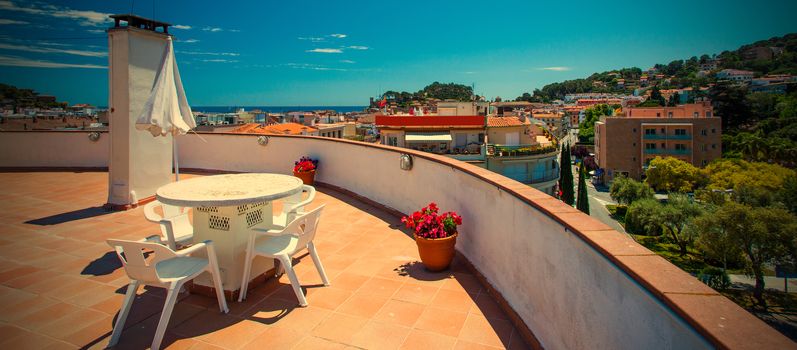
[144,200,194,250]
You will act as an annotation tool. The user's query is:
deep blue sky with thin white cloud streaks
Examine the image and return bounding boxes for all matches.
[0,0,797,106]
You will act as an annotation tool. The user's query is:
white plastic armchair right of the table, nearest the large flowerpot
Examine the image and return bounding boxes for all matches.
[238,205,329,306]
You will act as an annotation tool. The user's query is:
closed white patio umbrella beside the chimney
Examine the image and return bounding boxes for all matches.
[136,37,196,181]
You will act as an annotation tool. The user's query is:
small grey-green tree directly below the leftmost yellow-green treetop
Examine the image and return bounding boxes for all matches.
[659,193,702,256]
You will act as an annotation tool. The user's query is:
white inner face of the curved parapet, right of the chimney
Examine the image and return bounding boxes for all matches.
[179,134,711,349]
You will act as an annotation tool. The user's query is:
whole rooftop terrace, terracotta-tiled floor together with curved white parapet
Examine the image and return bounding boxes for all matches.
[0,132,795,349]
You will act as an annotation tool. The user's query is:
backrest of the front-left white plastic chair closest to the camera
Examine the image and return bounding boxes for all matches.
[107,239,177,284]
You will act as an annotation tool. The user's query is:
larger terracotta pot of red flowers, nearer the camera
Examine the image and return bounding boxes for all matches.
[401,203,462,271]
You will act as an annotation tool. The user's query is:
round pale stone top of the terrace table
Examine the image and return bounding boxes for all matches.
[156,174,302,207]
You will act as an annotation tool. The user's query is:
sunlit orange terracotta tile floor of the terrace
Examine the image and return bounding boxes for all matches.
[0,172,526,350]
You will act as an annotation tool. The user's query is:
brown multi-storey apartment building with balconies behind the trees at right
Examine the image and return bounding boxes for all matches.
[595,100,722,183]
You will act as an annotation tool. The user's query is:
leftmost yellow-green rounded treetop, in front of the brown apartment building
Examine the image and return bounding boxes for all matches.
[645,157,702,192]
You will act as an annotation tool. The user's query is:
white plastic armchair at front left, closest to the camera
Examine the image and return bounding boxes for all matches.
[107,239,229,350]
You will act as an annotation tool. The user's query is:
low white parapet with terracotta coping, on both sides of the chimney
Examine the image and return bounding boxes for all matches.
[0,132,795,349]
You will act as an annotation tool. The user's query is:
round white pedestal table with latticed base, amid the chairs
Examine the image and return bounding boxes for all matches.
[156,174,302,292]
